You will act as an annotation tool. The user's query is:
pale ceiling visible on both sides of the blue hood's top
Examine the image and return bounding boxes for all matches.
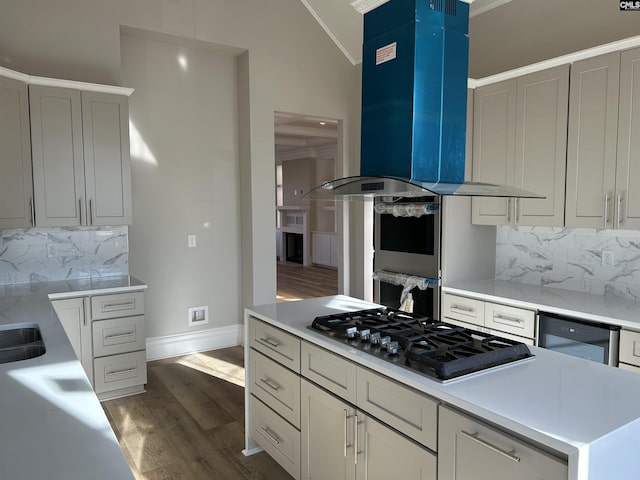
[300,0,511,65]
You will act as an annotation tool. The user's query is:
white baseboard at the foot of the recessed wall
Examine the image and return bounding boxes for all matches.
[147,325,244,361]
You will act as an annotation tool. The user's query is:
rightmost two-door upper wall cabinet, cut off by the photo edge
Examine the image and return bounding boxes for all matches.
[566,48,640,229]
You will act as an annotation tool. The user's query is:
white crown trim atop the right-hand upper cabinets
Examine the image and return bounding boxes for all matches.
[468,35,640,88]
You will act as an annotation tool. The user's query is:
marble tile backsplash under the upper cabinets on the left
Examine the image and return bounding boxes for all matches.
[0,226,129,285]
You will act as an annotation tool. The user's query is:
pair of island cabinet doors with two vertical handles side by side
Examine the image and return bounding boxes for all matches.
[300,379,437,480]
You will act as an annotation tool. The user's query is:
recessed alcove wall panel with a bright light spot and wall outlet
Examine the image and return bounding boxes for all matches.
[121,31,241,337]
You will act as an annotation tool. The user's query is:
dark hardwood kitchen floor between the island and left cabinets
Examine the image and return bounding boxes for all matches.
[102,347,291,480]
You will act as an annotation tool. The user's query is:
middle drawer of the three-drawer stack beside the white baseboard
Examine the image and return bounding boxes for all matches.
[92,315,145,357]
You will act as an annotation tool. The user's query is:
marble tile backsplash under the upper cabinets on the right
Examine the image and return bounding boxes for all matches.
[496,227,640,300]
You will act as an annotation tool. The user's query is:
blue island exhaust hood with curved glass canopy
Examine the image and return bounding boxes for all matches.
[307,0,544,199]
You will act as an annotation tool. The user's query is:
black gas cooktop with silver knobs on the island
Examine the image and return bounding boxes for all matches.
[310,307,533,382]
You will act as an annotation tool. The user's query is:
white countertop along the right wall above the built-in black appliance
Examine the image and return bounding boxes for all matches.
[442,280,640,329]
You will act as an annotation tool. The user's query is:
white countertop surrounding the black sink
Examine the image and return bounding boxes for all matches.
[0,277,146,480]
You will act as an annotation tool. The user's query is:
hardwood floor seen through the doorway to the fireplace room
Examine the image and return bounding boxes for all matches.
[277,262,338,302]
